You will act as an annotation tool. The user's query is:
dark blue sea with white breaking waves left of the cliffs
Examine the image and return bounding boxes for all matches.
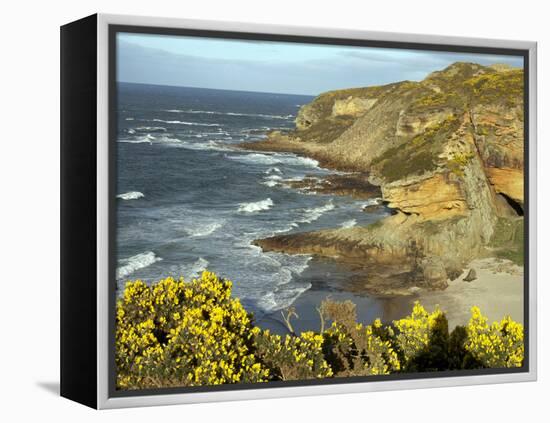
[116,83,385,322]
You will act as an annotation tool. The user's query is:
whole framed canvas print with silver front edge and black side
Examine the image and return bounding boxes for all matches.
[61,14,536,408]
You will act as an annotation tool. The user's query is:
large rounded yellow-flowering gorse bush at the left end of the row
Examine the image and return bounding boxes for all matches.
[116,272,269,388]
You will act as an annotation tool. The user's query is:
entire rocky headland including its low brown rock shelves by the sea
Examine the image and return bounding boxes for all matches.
[245,63,524,293]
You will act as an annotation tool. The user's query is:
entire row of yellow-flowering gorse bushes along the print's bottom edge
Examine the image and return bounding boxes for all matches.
[115,272,524,389]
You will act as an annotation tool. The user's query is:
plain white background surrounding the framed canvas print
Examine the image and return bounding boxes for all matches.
[0,0,550,423]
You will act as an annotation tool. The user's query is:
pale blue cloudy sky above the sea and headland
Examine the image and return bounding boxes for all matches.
[117,33,523,95]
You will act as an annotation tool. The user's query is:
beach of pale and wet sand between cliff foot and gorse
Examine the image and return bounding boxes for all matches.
[257,258,524,334]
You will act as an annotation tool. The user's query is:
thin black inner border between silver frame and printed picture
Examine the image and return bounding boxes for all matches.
[108,24,529,397]
